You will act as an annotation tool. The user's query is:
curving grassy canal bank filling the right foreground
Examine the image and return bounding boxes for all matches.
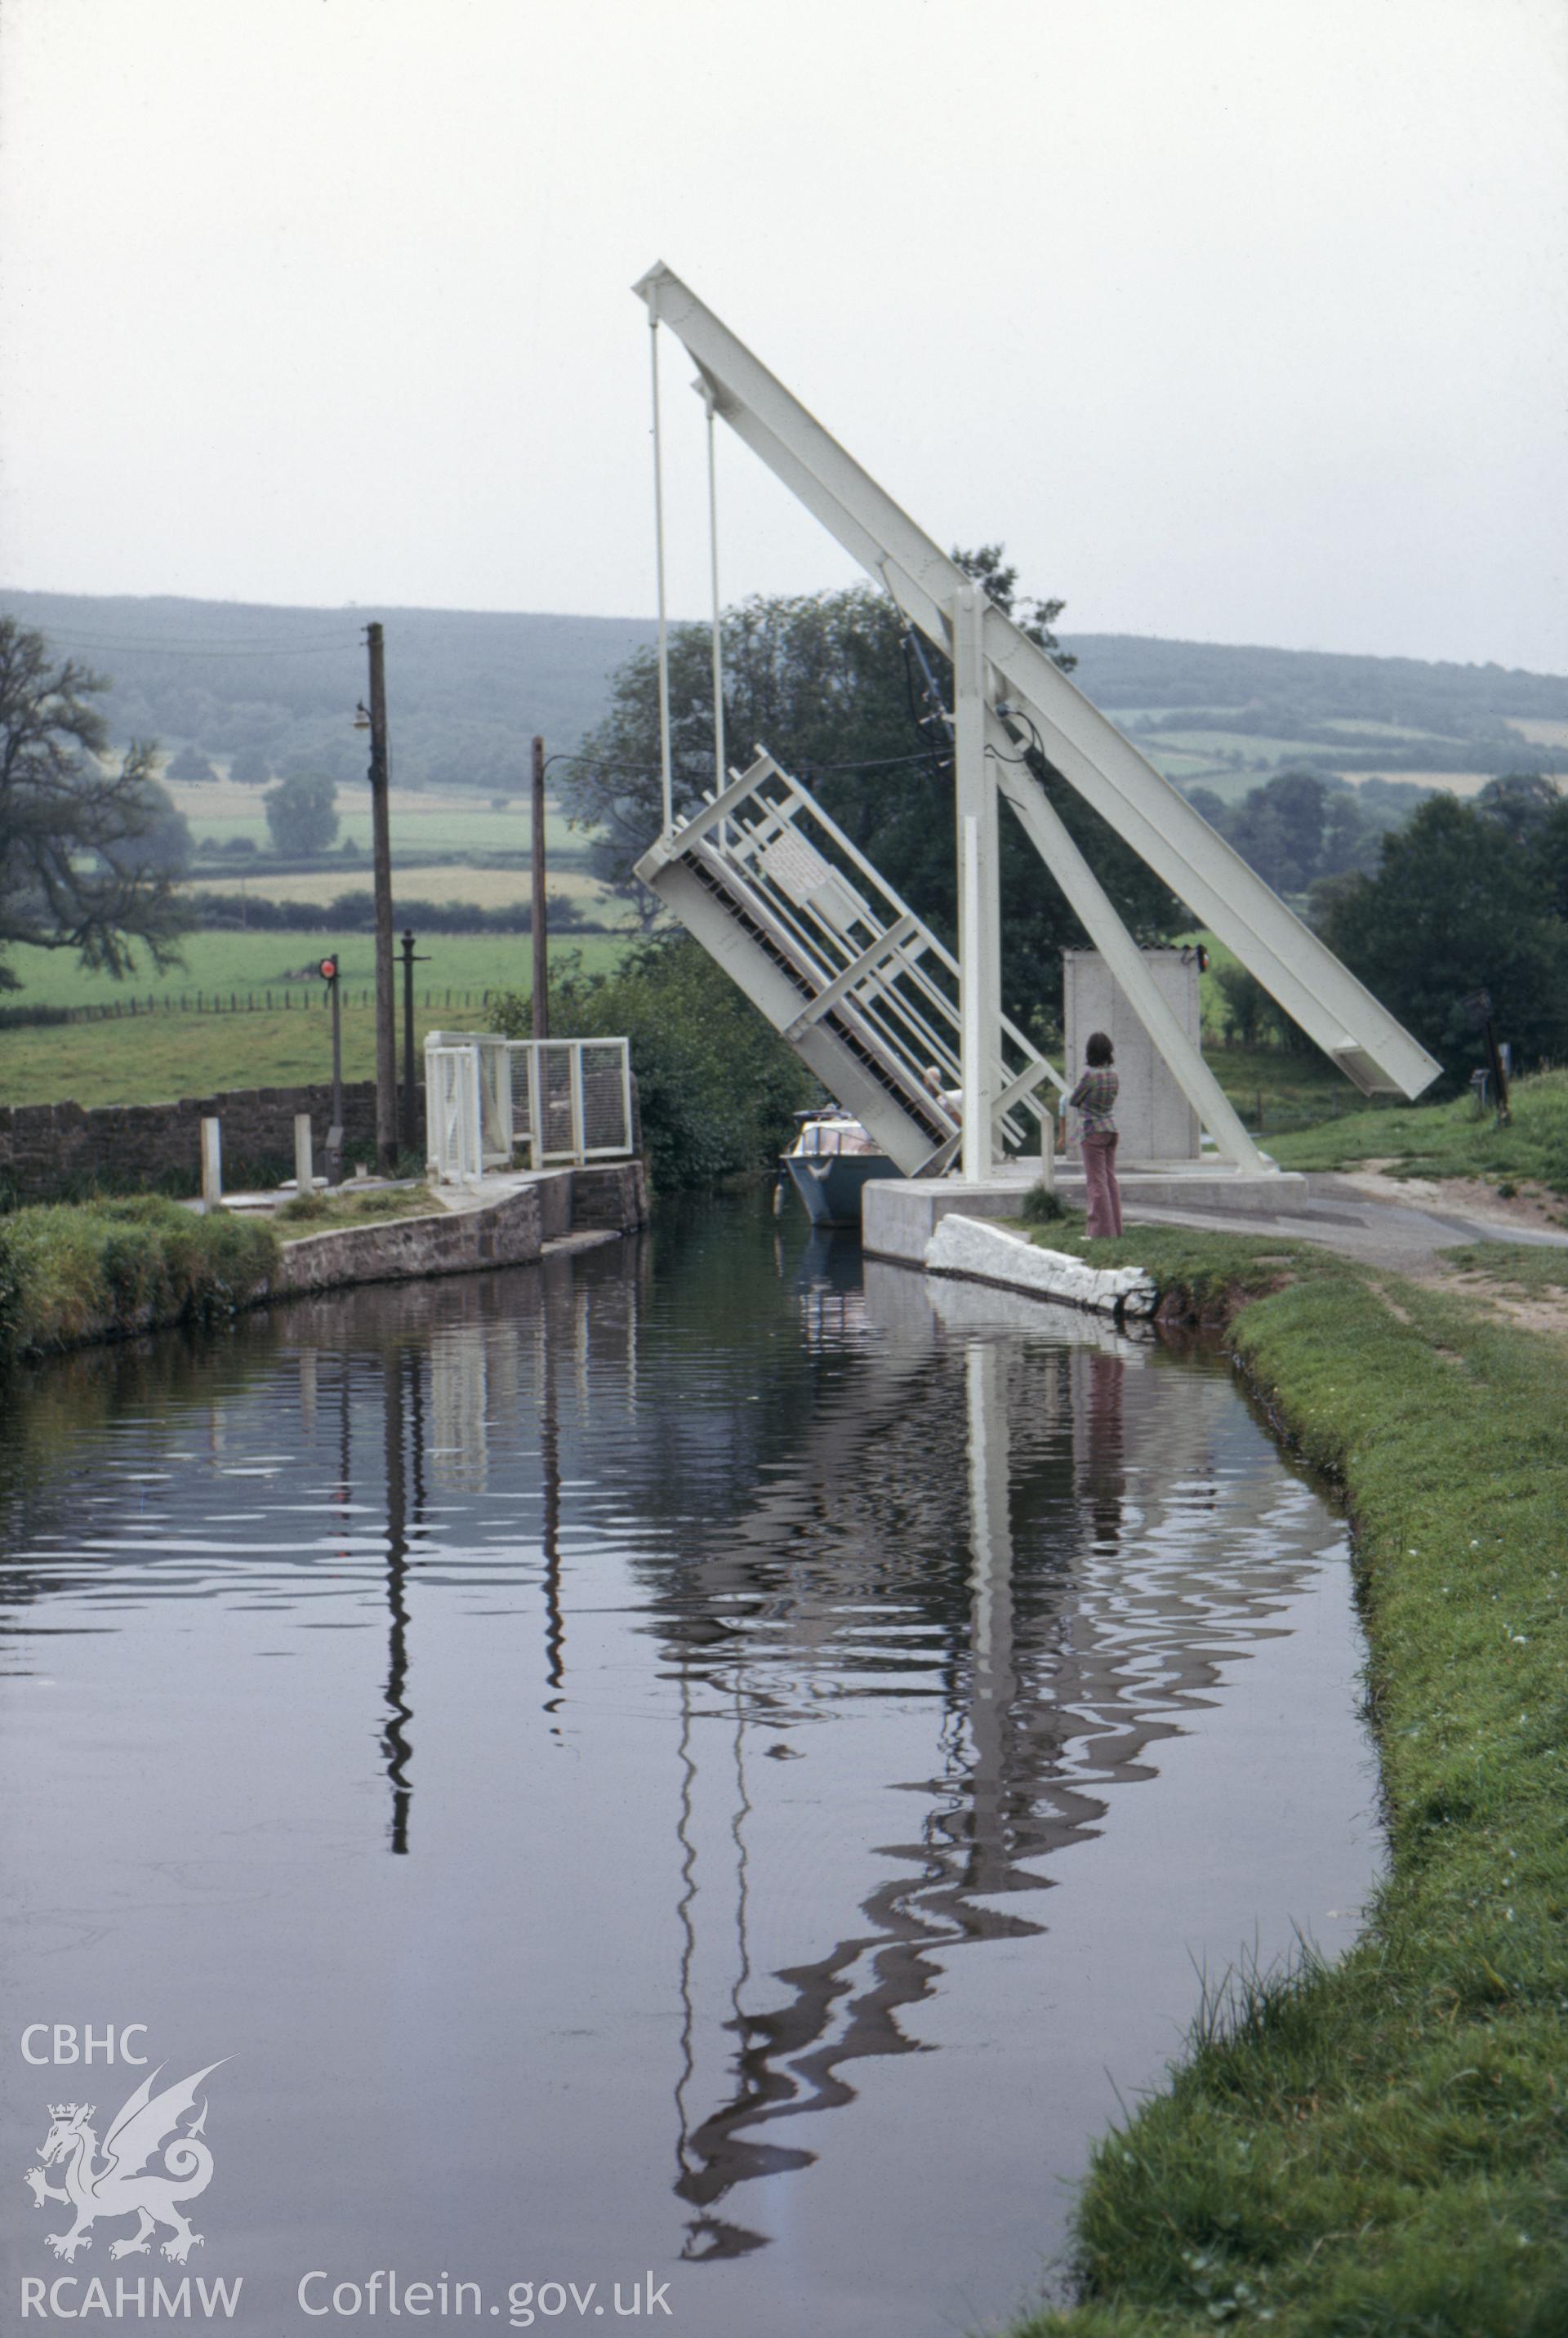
[1004,1227,1568,2338]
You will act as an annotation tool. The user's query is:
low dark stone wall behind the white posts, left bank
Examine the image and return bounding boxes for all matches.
[0,1080,411,1202]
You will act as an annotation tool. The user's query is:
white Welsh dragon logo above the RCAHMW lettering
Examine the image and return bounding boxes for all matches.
[25,2055,229,2265]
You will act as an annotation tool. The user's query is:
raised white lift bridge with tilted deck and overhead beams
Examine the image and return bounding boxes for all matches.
[635,266,1440,1181]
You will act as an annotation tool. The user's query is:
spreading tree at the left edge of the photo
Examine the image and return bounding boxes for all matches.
[0,617,192,989]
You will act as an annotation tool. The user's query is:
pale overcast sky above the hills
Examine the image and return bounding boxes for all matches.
[0,0,1568,674]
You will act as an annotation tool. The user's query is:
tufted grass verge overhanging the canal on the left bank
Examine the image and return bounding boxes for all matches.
[0,1195,278,1358]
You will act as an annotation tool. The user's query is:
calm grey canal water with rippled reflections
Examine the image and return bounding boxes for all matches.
[0,1202,1379,2338]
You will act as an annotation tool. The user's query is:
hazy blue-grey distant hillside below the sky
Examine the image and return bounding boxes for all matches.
[0,591,1568,795]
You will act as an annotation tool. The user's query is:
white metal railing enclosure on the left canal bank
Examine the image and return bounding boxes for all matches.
[425,1031,635,1186]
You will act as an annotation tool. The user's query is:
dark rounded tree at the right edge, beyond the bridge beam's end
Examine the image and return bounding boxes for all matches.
[1323,795,1568,1080]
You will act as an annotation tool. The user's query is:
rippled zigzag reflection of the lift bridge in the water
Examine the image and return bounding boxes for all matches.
[659,1274,1327,2256]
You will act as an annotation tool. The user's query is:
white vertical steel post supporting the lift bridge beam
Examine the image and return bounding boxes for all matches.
[951,585,1003,1186]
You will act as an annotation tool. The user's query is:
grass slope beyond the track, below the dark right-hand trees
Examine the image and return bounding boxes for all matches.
[1269,1071,1568,1195]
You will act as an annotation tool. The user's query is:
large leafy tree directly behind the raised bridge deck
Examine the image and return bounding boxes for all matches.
[564,545,1185,1029]
